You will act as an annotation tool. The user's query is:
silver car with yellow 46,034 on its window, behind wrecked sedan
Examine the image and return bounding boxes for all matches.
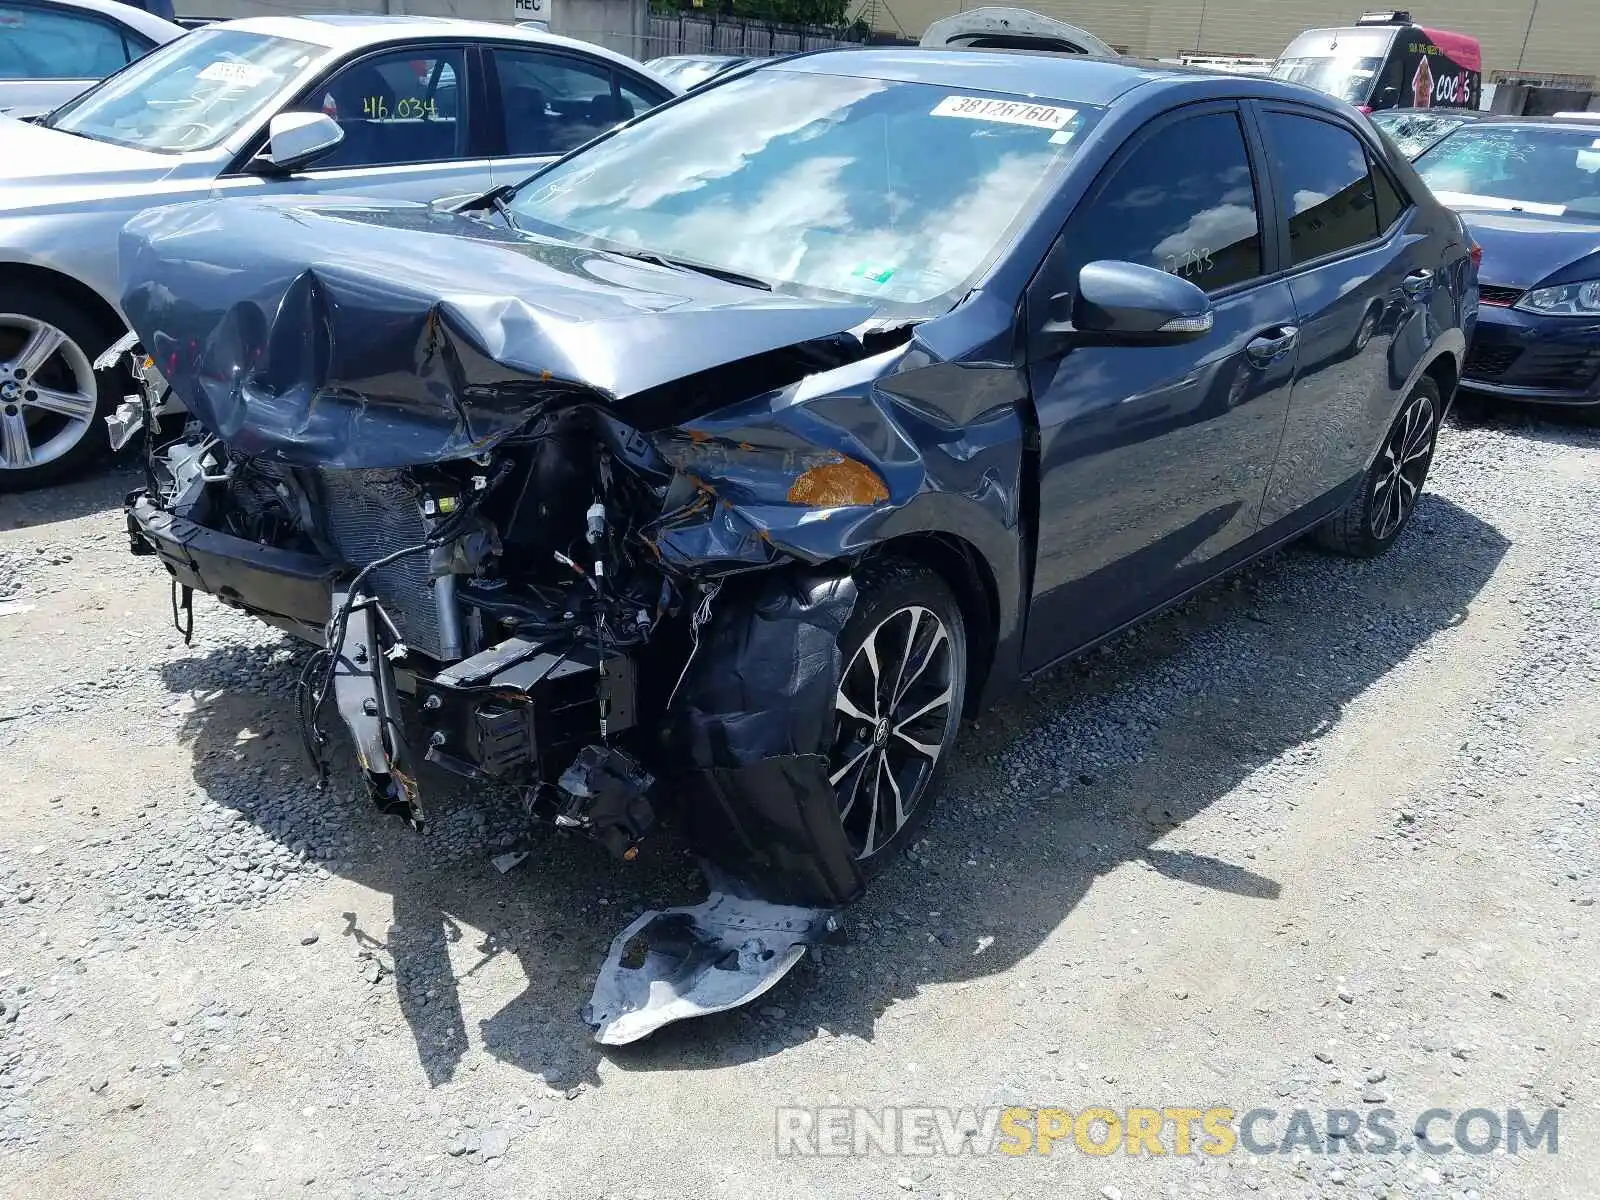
[0,11,678,491]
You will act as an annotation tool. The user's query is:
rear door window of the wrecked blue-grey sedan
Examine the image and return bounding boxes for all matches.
[1262,112,1398,266]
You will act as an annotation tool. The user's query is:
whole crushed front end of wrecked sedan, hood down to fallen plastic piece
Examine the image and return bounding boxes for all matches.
[109,202,1021,1042]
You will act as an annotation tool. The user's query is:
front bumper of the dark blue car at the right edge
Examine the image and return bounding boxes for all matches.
[1461,304,1600,405]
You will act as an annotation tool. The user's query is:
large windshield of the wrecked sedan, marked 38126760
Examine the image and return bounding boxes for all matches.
[510,69,1099,310]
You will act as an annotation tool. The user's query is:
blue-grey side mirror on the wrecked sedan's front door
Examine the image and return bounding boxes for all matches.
[1043,259,1213,346]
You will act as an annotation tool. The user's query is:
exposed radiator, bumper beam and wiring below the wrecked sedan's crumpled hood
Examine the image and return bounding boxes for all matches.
[128,406,688,856]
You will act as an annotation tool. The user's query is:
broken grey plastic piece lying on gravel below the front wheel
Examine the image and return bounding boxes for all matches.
[584,891,838,1046]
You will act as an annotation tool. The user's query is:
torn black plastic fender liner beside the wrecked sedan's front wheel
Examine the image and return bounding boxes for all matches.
[664,568,866,909]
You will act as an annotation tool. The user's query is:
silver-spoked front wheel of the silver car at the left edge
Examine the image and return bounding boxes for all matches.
[0,285,117,491]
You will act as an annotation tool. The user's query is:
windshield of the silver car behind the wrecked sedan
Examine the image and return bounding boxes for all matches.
[42,29,326,154]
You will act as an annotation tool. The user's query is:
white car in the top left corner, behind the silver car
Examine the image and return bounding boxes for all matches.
[0,0,186,114]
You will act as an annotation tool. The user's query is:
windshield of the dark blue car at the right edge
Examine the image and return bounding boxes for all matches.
[1416,125,1600,216]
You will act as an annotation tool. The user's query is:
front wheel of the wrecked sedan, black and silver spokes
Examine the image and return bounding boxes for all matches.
[829,560,966,875]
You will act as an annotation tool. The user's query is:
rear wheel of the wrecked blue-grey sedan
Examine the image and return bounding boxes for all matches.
[1312,376,1443,558]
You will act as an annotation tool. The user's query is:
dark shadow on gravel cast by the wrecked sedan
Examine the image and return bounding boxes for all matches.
[152,496,1507,1088]
